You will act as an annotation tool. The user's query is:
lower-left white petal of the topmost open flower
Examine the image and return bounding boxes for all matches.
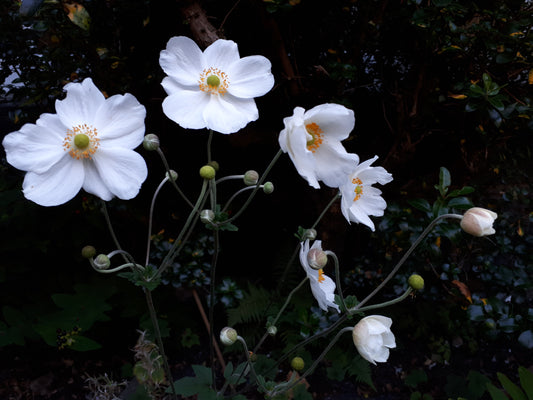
[163,87,210,129]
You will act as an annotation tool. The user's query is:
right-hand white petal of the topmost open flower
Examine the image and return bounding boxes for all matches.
[227,56,274,98]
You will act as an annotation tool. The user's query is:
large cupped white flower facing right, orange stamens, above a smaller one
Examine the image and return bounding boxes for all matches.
[279,104,359,189]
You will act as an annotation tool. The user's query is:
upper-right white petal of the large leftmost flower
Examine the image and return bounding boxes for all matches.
[95,93,146,149]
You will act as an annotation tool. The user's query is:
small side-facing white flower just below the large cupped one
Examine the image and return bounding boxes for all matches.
[340,156,392,230]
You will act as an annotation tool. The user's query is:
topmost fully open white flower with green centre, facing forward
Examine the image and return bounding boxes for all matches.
[159,36,274,133]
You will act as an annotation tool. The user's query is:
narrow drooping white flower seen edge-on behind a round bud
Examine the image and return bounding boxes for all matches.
[300,239,340,312]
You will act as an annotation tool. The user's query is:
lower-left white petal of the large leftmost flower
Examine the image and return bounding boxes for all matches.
[22,156,85,206]
